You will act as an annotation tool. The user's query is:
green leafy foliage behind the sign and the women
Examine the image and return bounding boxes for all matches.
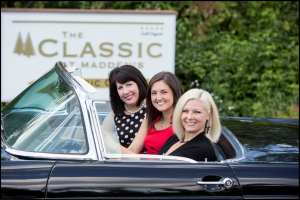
[1,1,299,119]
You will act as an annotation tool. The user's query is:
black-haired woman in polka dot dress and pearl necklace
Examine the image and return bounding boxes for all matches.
[102,65,148,153]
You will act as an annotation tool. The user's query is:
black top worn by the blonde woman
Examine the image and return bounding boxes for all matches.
[157,131,217,161]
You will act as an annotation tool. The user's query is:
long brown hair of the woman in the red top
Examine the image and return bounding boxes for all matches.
[146,72,183,130]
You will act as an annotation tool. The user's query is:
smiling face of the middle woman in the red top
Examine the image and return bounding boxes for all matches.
[151,81,174,112]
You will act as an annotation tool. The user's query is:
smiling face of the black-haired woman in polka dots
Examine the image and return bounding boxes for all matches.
[116,81,139,106]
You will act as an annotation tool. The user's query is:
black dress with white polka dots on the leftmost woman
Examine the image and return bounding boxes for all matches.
[115,105,147,153]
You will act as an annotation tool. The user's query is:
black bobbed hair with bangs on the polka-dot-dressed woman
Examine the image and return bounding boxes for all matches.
[108,65,148,114]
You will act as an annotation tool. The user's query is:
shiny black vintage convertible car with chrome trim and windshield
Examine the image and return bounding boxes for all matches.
[1,62,299,199]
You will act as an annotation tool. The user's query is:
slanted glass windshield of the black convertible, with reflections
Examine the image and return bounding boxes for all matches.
[2,69,87,154]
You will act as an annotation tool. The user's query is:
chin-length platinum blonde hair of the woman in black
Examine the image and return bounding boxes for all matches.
[173,89,221,142]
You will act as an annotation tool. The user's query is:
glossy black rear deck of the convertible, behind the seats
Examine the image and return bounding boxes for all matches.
[221,117,299,164]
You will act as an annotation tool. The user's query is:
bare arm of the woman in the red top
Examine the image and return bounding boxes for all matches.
[126,117,148,153]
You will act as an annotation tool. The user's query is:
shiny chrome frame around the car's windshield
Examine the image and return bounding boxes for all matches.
[1,62,101,160]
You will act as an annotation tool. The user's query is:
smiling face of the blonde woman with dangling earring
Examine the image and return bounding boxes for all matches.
[181,99,211,133]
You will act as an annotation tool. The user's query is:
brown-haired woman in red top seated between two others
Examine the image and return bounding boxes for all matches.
[122,72,183,154]
